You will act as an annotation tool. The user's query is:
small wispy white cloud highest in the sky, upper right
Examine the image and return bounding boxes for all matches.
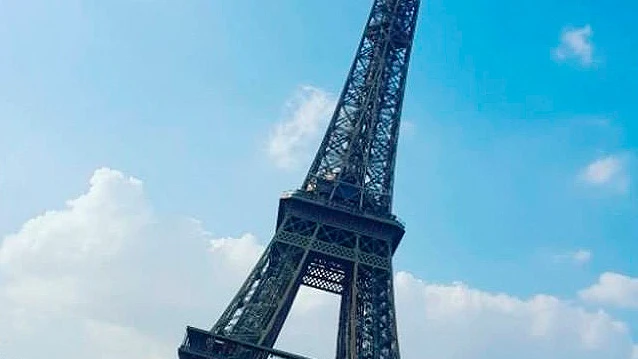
[552,25,594,67]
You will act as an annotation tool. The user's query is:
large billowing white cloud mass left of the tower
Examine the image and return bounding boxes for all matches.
[0,169,241,359]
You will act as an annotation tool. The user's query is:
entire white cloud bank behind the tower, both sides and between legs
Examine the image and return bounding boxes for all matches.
[0,169,634,359]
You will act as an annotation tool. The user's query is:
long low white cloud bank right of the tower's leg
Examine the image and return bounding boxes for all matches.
[396,273,632,359]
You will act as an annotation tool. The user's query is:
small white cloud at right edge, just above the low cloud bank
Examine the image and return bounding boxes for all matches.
[579,272,638,309]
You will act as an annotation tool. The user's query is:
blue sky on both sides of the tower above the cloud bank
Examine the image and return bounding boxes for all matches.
[0,0,638,355]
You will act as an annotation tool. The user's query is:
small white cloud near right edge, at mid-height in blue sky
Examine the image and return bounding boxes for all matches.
[579,155,629,193]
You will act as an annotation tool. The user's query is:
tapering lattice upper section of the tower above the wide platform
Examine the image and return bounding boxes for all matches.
[300,0,420,217]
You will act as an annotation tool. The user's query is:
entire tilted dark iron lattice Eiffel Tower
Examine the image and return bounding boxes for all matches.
[178,0,420,359]
